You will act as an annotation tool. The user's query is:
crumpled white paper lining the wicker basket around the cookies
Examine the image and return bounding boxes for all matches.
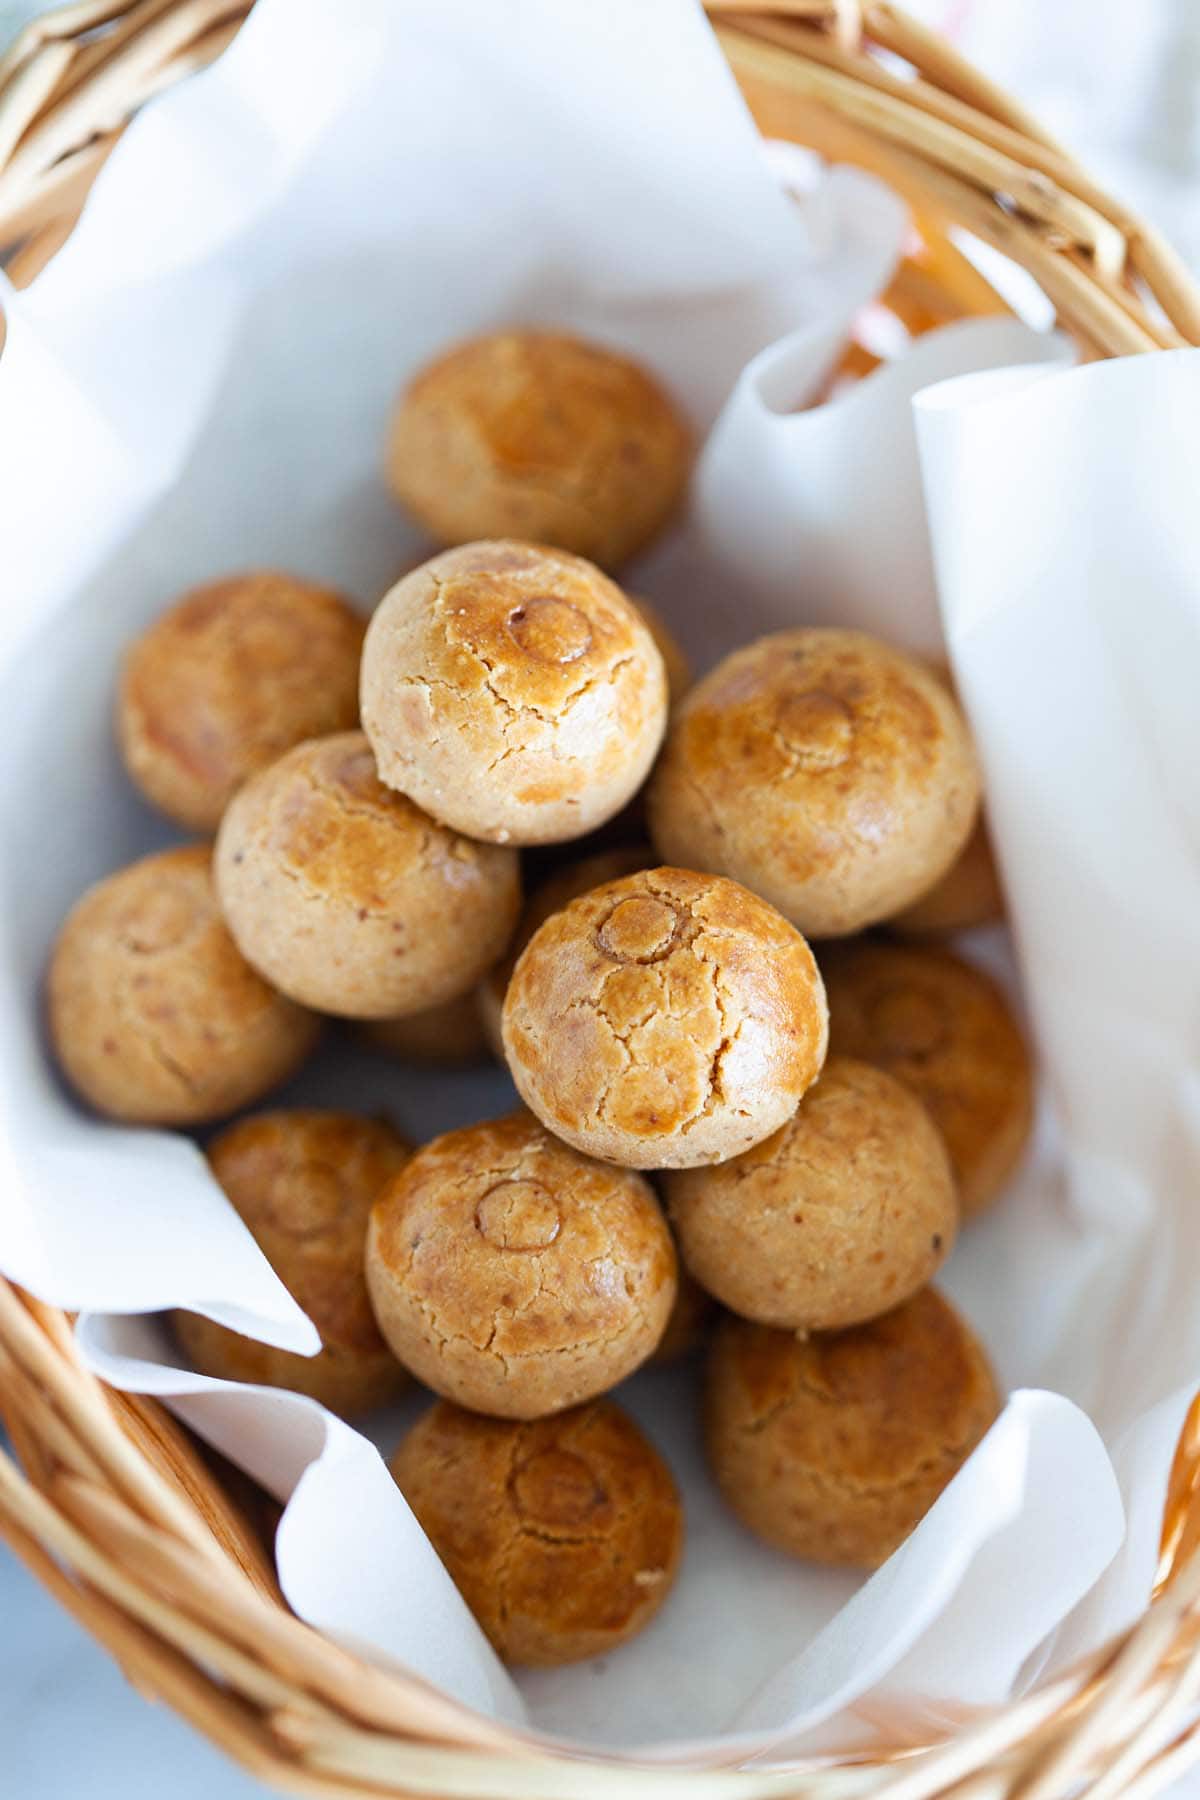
[0,0,1200,1760]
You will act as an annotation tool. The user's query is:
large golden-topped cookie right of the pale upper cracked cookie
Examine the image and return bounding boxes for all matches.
[646,630,979,938]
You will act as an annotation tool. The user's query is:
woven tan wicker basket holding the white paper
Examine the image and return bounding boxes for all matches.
[0,0,1200,1800]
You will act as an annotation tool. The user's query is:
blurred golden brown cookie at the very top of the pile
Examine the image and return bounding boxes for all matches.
[379,331,691,569]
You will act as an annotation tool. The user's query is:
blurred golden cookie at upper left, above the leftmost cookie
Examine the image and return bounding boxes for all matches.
[117,569,365,832]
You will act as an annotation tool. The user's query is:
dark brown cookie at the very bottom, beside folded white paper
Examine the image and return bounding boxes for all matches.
[390,1400,684,1669]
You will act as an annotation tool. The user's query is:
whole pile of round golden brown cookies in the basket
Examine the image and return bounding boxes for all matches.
[47,331,1031,1663]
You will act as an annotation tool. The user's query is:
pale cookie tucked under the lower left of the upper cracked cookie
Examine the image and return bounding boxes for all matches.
[216,731,520,1019]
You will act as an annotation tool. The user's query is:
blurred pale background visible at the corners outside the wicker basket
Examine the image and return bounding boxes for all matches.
[0,0,1200,1800]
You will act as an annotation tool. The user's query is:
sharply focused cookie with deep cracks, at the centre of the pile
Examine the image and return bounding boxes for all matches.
[502,869,828,1168]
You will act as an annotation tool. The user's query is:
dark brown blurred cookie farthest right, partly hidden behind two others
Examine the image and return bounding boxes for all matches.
[820,940,1033,1219]
